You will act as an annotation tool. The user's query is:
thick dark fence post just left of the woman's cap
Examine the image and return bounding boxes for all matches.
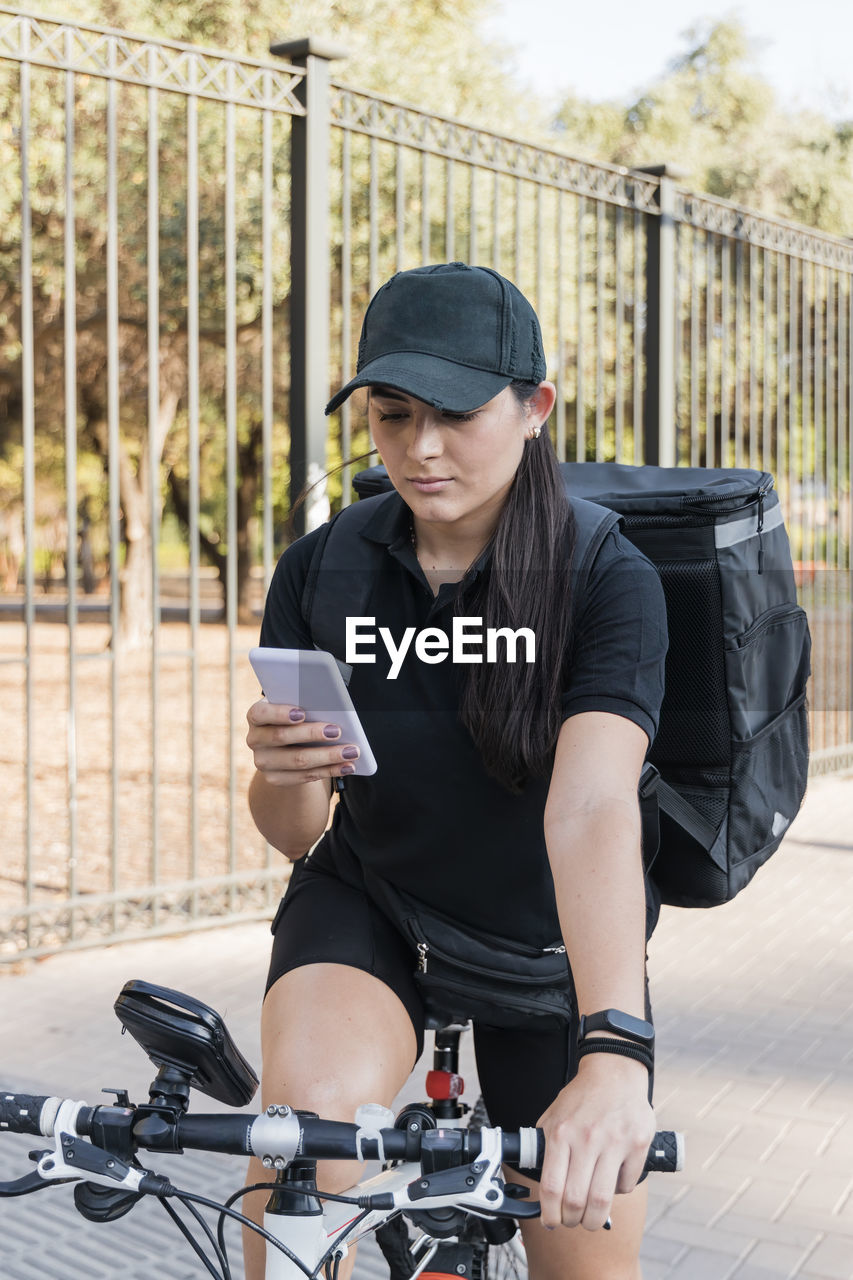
[270,36,348,534]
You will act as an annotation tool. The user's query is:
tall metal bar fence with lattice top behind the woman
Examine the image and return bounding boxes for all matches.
[0,6,853,959]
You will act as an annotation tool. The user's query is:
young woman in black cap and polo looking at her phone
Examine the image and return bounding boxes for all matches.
[247,262,666,1280]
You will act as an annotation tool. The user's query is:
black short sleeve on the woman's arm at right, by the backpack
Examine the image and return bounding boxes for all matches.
[562,530,667,742]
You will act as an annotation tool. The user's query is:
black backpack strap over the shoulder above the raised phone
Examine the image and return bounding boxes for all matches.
[301,493,393,684]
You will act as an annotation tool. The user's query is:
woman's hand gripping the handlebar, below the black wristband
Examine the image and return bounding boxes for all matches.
[539,1053,654,1231]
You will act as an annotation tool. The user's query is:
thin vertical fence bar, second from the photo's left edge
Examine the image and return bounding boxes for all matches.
[63,49,78,896]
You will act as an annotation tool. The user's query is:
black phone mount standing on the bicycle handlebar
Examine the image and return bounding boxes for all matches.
[114,979,257,1111]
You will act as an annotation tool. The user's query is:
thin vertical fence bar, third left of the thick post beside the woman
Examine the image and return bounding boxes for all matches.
[187,70,201,890]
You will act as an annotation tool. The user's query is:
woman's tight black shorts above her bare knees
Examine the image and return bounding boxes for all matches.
[266,846,652,1152]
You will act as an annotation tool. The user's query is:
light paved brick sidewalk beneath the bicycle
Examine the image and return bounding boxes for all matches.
[0,776,853,1280]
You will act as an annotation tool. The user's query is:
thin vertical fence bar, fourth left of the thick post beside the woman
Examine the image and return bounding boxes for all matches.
[147,57,160,905]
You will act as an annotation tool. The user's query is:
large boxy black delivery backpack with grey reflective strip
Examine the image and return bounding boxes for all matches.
[302,462,811,906]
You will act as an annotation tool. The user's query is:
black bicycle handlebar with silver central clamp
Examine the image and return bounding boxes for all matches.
[0,1092,684,1194]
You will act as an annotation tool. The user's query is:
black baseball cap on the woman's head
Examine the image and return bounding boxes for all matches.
[325,262,546,413]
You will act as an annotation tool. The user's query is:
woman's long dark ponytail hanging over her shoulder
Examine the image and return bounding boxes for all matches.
[456,383,574,794]
